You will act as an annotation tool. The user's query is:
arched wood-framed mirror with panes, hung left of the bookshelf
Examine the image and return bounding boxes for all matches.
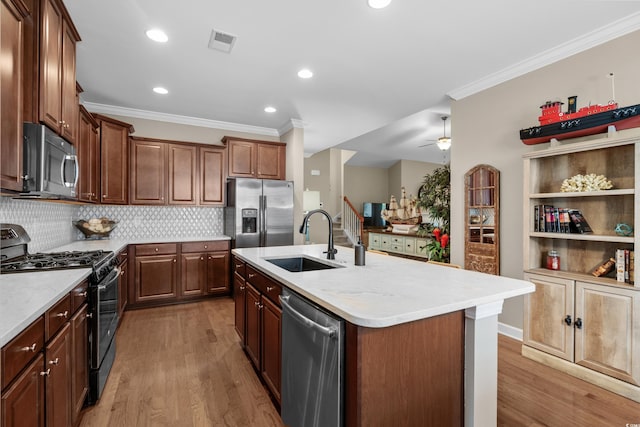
[464,165,500,275]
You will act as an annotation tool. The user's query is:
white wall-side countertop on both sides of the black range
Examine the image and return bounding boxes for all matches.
[0,236,230,347]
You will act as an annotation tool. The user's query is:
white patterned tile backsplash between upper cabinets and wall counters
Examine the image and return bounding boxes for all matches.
[0,197,224,253]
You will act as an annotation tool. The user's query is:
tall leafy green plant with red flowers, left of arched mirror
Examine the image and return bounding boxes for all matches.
[418,165,451,262]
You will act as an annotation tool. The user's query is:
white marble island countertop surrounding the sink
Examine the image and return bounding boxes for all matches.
[232,245,535,328]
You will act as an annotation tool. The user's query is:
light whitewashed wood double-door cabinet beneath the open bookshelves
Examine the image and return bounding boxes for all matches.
[523,274,640,391]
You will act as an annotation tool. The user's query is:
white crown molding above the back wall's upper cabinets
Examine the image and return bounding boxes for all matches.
[82,102,281,137]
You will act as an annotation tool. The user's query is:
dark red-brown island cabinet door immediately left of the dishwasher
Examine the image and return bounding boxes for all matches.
[261,296,282,403]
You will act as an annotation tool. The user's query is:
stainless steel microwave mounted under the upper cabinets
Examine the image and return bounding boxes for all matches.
[21,123,78,199]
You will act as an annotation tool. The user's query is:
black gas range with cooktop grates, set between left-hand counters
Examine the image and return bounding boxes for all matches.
[0,224,120,404]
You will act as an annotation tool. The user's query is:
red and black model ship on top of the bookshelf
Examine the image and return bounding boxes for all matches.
[520,96,640,145]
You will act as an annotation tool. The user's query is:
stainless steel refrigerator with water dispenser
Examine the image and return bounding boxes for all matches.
[224,178,293,248]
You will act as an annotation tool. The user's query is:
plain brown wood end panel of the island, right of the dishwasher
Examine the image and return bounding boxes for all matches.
[345,311,464,427]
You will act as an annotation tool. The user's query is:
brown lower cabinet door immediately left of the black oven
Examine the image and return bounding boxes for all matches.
[70,304,89,425]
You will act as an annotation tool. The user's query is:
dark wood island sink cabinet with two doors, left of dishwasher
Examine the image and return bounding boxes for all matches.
[242,266,282,403]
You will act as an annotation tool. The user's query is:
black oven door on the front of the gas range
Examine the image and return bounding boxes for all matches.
[90,268,120,369]
